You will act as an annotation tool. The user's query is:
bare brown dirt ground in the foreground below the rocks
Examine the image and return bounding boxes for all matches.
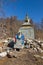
[0,49,43,65]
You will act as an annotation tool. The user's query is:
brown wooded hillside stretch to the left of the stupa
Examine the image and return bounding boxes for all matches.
[0,16,22,37]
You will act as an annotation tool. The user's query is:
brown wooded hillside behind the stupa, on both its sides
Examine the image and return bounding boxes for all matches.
[0,16,43,39]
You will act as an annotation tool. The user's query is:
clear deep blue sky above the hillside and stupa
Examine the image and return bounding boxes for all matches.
[0,0,43,22]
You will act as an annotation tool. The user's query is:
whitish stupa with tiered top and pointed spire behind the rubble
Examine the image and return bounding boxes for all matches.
[19,15,35,39]
